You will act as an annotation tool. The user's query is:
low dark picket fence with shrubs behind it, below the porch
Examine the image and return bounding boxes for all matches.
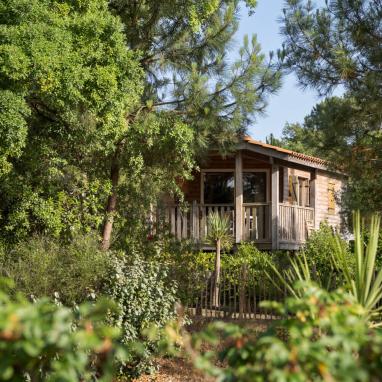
[181,266,287,320]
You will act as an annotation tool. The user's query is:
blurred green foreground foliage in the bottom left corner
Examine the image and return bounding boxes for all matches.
[0,286,127,382]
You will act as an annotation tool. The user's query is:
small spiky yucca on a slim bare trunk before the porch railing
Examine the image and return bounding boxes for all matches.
[207,212,233,307]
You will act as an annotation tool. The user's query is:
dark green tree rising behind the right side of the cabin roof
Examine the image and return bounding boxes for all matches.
[274,96,382,213]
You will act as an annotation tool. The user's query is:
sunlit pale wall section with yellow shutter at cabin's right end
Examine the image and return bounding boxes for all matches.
[315,170,344,228]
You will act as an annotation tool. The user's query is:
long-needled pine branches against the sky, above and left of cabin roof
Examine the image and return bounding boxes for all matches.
[111,0,280,146]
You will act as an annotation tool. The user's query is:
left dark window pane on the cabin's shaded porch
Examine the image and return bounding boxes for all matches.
[204,172,235,204]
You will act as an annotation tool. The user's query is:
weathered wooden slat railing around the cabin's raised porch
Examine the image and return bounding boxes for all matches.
[161,202,314,250]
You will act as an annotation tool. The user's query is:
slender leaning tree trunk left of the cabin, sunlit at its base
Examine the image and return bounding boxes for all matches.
[102,151,119,251]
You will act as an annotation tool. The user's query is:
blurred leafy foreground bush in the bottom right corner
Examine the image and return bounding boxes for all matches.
[188,284,382,381]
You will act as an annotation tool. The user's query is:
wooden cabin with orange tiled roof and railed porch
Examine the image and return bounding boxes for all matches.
[165,137,345,250]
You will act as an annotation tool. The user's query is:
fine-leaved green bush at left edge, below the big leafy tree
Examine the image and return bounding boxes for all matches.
[0,235,110,306]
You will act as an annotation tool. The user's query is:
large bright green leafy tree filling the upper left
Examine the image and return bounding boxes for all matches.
[0,0,143,240]
